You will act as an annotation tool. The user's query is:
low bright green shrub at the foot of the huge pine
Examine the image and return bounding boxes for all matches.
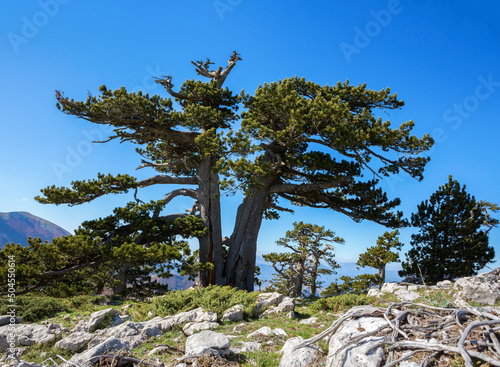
[149,285,258,317]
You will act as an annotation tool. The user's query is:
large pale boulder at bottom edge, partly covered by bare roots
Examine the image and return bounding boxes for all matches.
[326,316,387,367]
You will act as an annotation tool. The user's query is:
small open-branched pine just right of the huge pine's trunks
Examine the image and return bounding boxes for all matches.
[263,222,344,297]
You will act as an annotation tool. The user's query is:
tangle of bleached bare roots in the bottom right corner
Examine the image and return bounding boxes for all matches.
[296,302,500,367]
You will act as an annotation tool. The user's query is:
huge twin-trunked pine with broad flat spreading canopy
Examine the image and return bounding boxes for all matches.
[23,52,433,290]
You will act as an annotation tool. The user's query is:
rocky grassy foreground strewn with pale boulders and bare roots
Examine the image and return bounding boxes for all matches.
[0,269,500,367]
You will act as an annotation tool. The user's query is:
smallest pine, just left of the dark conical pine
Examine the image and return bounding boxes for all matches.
[356,230,403,283]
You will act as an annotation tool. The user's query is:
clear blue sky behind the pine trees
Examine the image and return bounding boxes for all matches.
[0,0,500,272]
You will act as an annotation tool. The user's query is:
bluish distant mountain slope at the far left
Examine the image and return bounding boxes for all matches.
[0,212,71,248]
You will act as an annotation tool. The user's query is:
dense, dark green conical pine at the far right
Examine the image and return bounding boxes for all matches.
[400,176,498,283]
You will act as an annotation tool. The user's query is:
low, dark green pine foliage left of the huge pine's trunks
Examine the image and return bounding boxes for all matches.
[0,202,205,297]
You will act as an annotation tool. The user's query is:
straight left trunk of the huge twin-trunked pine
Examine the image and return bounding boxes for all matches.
[197,157,225,287]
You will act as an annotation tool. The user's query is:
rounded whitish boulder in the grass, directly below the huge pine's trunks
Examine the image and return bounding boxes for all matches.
[183,330,231,359]
